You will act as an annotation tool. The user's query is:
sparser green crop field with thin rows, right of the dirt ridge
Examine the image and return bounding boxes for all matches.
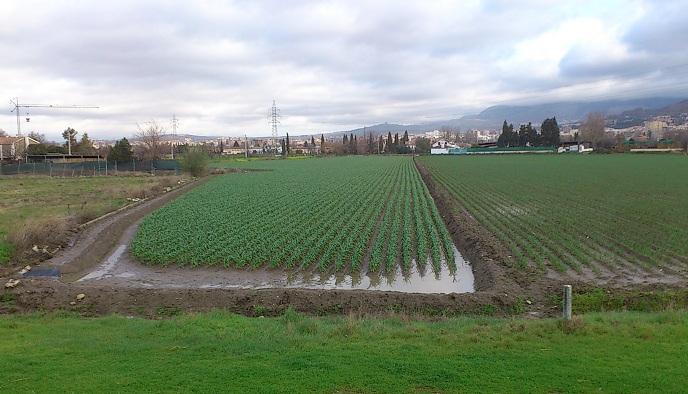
[420,155,688,270]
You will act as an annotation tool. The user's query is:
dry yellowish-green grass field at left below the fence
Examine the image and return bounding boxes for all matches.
[0,176,184,264]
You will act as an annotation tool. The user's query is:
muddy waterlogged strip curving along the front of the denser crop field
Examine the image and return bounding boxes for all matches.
[77,244,475,294]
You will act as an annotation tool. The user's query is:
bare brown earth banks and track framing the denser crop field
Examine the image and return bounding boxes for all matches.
[0,162,684,317]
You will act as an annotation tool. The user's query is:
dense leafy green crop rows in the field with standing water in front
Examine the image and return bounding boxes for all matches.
[132,157,455,272]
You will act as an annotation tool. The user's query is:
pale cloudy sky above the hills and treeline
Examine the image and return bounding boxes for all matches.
[0,0,688,139]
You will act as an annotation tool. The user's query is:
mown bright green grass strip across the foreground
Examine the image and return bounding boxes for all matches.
[0,311,688,393]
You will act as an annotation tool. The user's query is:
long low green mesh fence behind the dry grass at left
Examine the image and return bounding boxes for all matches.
[0,160,181,177]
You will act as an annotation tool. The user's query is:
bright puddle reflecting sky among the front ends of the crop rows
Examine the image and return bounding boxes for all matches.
[276,247,475,293]
